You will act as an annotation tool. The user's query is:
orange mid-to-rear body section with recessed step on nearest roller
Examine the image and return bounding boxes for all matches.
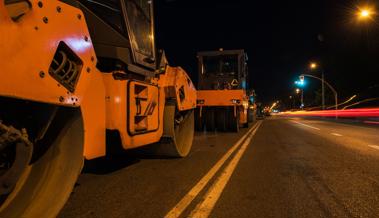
[103,66,196,149]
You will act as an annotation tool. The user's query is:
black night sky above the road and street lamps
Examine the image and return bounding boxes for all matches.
[155,0,379,103]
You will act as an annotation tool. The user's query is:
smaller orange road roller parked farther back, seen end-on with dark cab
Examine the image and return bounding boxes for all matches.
[196,49,254,132]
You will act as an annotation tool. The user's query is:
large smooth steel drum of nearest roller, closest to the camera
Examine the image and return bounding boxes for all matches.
[0,112,84,218]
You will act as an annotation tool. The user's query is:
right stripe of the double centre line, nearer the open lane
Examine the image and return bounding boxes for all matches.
[189,124,260,218]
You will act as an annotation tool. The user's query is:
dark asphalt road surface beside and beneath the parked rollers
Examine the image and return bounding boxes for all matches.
[59,118,379,218]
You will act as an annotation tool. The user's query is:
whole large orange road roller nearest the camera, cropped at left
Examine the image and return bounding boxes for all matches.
[0,0,196,218]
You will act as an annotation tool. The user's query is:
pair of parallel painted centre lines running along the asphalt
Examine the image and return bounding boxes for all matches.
[165,121,262,218]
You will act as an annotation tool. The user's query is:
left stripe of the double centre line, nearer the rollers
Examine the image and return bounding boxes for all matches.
[165,121,262,218]
